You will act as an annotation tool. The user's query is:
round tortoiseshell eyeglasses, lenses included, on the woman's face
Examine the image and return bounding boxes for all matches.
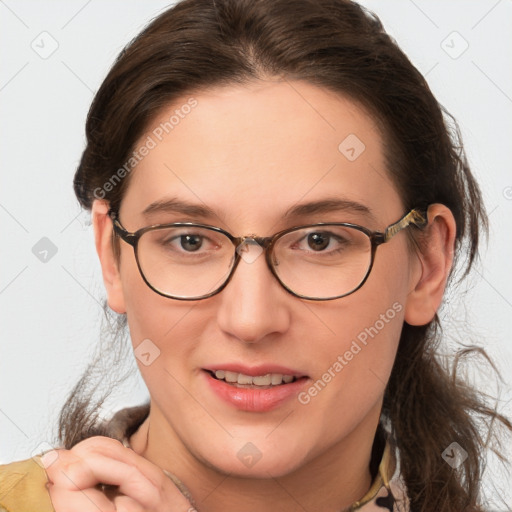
[109,208,428,301]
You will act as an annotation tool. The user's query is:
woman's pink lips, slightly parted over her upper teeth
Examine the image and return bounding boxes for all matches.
[202,364,309,413]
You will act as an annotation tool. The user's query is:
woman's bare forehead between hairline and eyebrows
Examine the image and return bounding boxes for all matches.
[123,81,397,228]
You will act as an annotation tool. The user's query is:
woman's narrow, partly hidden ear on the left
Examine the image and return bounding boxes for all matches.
[91,199,126,313]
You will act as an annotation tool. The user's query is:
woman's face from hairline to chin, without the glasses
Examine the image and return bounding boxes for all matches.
[99,81,419,477]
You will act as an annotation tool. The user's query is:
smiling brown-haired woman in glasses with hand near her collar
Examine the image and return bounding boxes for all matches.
[0,0,512,512]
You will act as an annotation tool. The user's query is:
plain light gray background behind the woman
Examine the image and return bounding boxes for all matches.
[0,0,512,510]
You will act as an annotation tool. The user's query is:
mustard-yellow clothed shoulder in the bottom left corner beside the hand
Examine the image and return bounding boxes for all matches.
[0,457,54,512]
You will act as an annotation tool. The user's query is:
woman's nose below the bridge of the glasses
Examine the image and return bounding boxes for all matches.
[217,244,290,343]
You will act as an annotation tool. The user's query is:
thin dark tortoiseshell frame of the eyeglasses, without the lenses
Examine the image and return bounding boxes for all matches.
[107,206,429,301]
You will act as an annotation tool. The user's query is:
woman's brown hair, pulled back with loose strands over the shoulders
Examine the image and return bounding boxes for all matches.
[59,0,512,512]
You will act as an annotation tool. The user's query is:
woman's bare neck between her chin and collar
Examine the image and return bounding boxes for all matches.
[130,404,380,512]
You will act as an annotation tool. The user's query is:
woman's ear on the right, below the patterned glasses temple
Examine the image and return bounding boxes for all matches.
[405,204,456,325]
